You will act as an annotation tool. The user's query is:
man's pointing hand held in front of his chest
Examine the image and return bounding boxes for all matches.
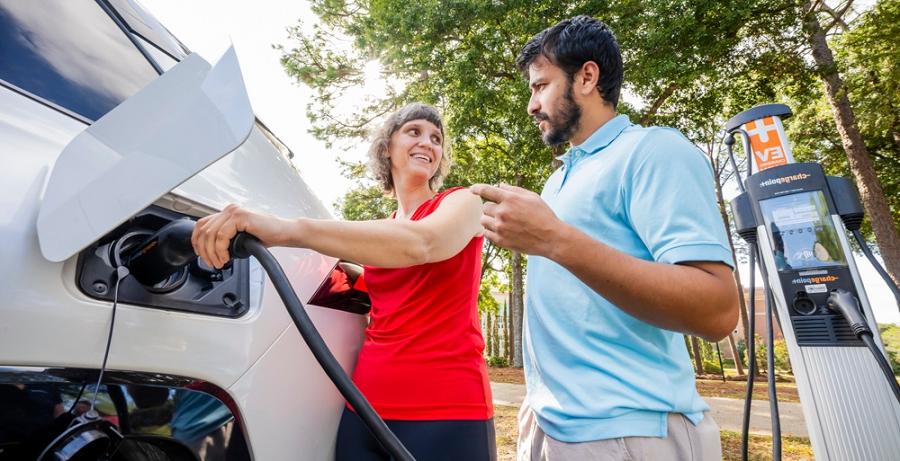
[469,184,563,257]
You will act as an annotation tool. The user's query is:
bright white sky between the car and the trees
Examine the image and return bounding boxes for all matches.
[140,0,900,323]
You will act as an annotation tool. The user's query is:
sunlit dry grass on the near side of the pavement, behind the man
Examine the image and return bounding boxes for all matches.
[494,405,813,461]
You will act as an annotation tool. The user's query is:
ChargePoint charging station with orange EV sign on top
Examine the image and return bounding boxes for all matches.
[726,104,900,460]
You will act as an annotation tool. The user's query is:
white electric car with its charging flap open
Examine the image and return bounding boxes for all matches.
[0,0,368,461]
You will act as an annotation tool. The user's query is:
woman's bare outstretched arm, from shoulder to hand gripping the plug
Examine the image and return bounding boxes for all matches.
[191,189,483,268]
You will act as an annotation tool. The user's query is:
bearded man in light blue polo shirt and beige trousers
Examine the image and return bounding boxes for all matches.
[471,16,737,461]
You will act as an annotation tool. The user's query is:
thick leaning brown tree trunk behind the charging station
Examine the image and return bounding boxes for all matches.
[803,2,900,283]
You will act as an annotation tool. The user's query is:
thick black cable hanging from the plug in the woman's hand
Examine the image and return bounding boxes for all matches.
[230,232,415,461]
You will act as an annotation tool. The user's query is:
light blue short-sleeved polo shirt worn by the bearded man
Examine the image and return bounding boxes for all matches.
[523,115,734,442]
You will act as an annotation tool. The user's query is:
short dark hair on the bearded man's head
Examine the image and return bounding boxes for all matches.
[516,15,622,107]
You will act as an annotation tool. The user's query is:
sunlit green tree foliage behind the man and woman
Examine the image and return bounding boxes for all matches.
[282,0,900,237]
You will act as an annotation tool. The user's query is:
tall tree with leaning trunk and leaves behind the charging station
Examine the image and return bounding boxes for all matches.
[786,0,900,283]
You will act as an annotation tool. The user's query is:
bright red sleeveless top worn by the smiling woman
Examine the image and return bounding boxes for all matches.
[353,187,494,421]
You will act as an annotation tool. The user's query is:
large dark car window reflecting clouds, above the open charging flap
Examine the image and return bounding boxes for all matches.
[0,0,159,120]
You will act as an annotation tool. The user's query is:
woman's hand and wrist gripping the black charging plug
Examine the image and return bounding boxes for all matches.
[191,204,293,269]
